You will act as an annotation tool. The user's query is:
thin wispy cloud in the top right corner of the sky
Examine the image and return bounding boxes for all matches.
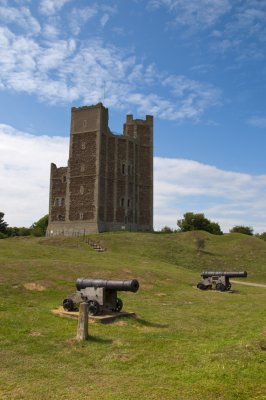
[148,0,266,62]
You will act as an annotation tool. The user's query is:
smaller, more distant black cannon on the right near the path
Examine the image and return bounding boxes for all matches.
[197,271,248,292]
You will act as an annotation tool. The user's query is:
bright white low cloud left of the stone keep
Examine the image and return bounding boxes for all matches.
[0,124,68,226]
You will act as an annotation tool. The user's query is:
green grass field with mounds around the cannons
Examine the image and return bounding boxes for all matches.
[0,232,266,400]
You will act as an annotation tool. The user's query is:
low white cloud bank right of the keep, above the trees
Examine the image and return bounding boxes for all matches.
[154,157,266,232]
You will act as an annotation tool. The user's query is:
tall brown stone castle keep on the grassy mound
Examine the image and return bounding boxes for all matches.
[47,103,153,236]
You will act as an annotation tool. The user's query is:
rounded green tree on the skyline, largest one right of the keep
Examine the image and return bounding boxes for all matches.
[177,212,223,235]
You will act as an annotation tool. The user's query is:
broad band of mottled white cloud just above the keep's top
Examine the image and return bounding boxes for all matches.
[0,27,220,120]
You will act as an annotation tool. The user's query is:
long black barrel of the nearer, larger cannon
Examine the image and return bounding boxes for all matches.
[76,278,139,293]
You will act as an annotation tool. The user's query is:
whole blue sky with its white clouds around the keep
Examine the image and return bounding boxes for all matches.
[0,0,266,232]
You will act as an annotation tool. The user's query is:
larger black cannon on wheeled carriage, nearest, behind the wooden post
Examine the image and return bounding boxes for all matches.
[63,278,139,315]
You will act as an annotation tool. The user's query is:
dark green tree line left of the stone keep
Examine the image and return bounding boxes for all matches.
[0,211,48,239]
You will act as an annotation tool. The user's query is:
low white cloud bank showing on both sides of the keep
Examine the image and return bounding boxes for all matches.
[0,124,266,232]
